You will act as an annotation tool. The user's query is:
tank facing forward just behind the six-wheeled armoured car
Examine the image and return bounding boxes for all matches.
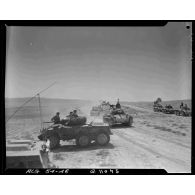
[103,108,133,127]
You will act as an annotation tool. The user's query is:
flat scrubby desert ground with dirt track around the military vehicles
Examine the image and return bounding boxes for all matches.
[5,98,191,173]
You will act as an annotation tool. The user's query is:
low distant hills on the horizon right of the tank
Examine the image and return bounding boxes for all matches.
[121,100,192,110]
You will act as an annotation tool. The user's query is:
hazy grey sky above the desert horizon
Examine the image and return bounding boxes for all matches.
[5,22,191,101]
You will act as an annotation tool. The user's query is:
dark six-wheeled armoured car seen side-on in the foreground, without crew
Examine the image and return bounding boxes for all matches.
[38,113,112,149]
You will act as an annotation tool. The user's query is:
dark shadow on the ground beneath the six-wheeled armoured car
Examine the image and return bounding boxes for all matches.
[51,143,114,153]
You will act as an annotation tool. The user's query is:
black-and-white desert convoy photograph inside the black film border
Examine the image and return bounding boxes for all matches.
[5,21,192,173]
